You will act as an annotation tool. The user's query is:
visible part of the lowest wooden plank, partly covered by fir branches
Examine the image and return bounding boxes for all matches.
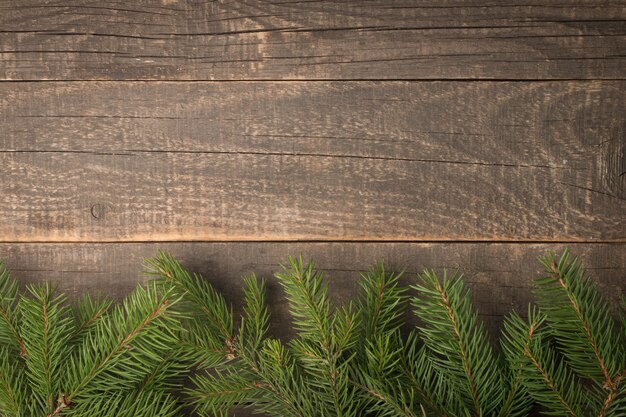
[0,242,626,334]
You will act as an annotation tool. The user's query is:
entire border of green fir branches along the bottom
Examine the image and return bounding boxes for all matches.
[0,251,626,417]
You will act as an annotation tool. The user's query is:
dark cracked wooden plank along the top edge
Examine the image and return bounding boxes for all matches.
[0,0,626,80]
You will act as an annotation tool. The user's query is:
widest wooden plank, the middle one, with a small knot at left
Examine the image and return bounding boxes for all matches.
[0,82,626,242]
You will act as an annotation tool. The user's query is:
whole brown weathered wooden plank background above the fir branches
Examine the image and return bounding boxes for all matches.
[0,0,626,344]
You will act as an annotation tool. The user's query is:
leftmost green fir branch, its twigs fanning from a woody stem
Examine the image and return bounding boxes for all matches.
[0,266,181,417]
